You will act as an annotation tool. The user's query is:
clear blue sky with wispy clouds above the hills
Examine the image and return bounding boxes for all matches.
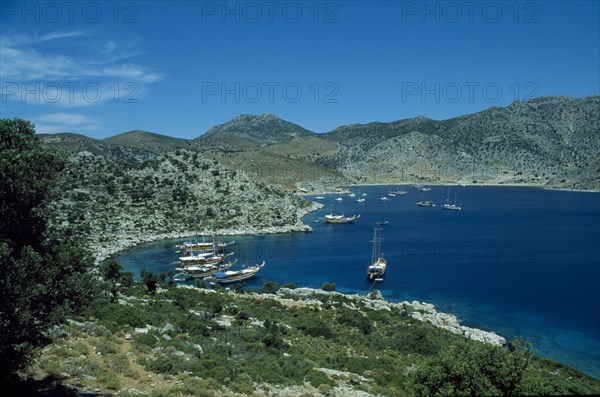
[0,0,600,138]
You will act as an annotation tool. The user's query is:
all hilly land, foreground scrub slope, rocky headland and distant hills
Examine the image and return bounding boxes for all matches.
[4,97,600,397]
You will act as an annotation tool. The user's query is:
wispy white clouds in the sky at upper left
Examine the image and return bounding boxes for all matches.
[0,31,165,107]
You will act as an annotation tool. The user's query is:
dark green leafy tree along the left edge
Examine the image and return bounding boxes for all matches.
[0,119,95,383]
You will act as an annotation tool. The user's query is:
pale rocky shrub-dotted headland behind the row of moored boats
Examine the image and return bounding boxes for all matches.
[43,146,315,260]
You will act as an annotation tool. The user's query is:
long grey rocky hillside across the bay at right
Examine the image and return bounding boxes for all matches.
[316,96,600,189]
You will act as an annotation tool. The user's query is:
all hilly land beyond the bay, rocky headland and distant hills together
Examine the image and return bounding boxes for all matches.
[39,96,600,258]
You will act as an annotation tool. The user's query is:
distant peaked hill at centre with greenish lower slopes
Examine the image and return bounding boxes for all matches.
[194,113,348,190]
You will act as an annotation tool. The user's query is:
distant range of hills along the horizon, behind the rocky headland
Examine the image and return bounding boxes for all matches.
[42,96,600,190]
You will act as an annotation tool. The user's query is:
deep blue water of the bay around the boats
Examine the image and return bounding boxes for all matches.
[118,186,600,378]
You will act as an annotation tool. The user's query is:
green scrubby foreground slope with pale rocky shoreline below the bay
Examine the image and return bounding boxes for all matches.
[23,283,600,397]
